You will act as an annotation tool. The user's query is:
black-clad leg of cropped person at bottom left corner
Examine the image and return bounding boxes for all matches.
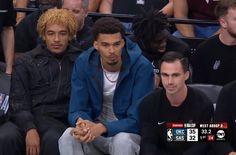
[0,121,25,155]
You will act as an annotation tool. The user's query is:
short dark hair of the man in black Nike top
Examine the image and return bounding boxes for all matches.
[159,51,189,72]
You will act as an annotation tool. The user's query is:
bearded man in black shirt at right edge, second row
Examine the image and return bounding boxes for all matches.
[192,0,236,86]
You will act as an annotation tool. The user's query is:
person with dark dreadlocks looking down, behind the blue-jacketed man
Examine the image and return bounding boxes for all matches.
[133,10,190,87]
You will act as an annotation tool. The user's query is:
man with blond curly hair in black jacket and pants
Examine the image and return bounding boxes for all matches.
[10,9,79,155]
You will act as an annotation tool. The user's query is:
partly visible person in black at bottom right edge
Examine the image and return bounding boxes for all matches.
[213,81,236,155]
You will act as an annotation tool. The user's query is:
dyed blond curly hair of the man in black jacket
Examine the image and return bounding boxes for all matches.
[37,8,78,40]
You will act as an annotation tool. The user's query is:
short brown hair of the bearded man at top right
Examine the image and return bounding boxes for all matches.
[215,0,236,18]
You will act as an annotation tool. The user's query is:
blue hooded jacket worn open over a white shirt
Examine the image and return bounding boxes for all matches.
[69,38,154,136]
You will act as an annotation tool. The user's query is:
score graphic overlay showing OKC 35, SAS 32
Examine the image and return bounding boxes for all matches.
[166,122,228,142]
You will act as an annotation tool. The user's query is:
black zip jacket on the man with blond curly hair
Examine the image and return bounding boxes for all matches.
[10,45,79,132]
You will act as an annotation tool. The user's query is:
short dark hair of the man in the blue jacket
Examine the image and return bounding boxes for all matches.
[92,17,125,40]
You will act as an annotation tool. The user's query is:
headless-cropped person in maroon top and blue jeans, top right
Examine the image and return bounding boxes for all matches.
[173,0,219,38]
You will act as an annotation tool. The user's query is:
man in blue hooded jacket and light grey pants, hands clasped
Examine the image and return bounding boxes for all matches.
[59,17,154,155]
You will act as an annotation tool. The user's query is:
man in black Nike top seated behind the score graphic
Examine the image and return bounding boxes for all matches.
[140,52,213,155]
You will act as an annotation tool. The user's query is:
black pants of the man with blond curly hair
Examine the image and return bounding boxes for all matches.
[36,116,68,155]
